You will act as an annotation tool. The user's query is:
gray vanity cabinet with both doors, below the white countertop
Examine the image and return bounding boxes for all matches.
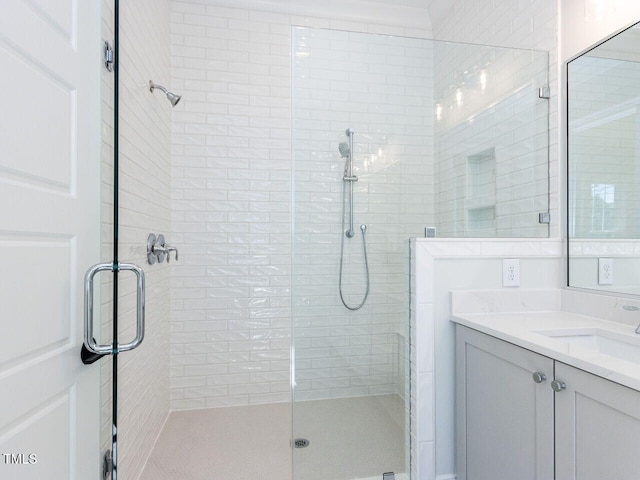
[456,325,640,480]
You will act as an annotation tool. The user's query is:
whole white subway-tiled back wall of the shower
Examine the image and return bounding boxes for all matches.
[172,2,546,408]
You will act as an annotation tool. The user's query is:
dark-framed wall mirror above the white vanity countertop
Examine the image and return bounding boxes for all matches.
[567,23,640,295]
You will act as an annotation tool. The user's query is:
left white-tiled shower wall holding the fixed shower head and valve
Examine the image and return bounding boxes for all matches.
[96,0,173,478]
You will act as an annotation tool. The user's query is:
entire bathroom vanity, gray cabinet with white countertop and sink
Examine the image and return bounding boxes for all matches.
[452,312,640,480]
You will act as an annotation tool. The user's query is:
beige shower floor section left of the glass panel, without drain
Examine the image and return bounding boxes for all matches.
[140,403,291,480]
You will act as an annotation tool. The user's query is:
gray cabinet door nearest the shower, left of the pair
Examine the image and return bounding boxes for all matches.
[456,325,556,480]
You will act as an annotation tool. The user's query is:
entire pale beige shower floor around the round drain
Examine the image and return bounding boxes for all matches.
[140,395,405,480]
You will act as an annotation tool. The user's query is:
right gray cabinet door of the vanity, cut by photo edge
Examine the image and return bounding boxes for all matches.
[555,362,640,480]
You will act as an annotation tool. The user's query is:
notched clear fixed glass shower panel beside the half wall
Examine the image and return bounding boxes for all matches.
[292,27,549,480]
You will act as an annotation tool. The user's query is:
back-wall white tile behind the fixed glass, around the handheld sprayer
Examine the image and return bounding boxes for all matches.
[293,27,434,400]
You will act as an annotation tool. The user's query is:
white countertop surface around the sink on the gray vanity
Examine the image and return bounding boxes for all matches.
[451,311,640,391]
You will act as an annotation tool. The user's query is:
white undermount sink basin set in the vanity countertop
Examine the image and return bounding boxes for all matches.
[533,328,640,364]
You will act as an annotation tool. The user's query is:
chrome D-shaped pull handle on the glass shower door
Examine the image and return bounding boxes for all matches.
[84,263,145,355]
